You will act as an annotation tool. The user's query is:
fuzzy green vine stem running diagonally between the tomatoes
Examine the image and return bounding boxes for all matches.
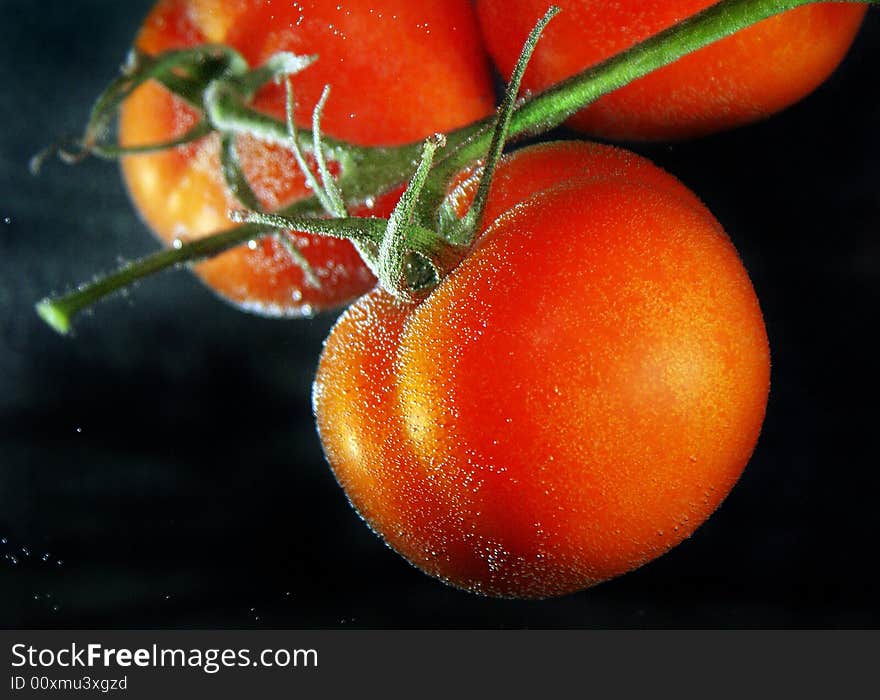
[34,0,880,333]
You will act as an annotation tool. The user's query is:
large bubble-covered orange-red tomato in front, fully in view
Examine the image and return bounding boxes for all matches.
[313,143,769,597]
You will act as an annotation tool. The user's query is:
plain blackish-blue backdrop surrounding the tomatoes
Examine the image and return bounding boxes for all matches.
[0,0,880,628]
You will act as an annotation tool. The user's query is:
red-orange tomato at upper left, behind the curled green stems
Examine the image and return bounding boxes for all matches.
[120,0,494,315]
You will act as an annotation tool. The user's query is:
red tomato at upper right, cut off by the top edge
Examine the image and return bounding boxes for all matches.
[477,0,867,140]
